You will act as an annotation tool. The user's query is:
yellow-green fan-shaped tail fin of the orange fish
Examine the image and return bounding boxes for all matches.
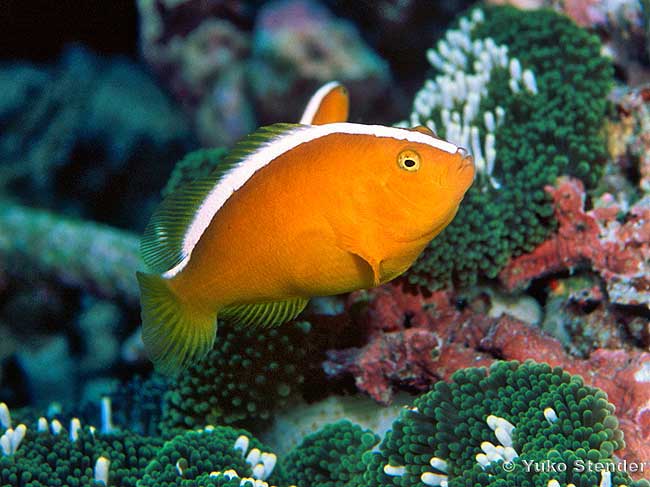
[136,272,217,374]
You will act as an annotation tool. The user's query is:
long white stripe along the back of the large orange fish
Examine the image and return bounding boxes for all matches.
[162,122,459,279]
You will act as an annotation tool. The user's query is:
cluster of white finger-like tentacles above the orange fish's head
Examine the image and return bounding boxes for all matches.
[403,9,537,189]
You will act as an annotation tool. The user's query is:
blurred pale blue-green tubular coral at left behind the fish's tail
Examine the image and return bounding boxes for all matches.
[0,200,140,302]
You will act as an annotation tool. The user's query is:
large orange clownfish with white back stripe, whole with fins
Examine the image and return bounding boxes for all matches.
[137,83,474,373]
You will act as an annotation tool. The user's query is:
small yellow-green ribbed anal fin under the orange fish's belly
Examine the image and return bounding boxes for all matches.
[219,298,309,328]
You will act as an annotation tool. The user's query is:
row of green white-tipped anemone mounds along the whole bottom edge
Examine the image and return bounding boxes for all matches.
[0,361,650,487]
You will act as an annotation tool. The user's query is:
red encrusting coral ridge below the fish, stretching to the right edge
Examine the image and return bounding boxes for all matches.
[324,285,650,474]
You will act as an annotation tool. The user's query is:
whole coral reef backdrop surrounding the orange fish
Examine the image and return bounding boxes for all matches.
[0,0,650,487]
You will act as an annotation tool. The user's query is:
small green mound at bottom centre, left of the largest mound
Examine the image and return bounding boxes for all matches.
[284,420,379,487]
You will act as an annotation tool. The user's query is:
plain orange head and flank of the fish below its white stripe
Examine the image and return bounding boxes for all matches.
[169,134,473,309]
